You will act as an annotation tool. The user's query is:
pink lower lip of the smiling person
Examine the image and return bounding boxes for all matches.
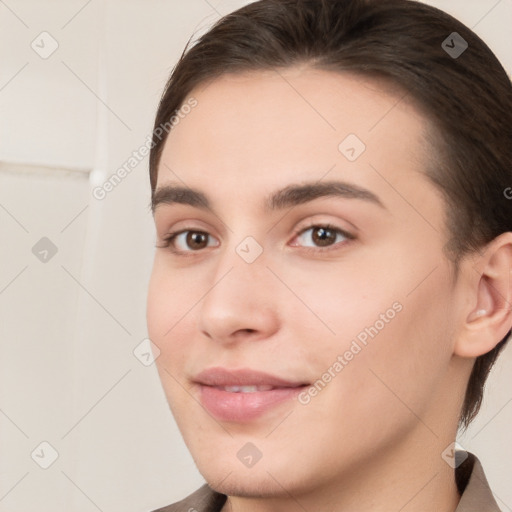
[200,385,307,422]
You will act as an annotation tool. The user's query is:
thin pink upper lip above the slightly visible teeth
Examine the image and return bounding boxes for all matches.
[194,367,306,388]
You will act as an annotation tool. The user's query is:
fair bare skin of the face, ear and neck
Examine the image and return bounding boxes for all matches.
[147,66,512,512]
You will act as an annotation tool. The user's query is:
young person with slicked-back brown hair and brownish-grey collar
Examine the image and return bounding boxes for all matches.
[147,0,512,512]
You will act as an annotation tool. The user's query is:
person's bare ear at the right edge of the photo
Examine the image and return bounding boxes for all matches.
[454,232,512,358]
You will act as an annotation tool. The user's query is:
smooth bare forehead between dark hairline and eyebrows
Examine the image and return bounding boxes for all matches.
[157,66,436,218]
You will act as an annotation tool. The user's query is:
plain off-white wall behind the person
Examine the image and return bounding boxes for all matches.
[0,0,512,512]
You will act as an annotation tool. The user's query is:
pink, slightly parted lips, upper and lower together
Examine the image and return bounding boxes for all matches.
[194,367,308,422]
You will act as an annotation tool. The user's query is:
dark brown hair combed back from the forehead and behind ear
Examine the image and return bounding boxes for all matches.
[149,0,512,428]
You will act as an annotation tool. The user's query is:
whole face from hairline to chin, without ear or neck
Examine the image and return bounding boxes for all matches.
[147,67,462,496]
